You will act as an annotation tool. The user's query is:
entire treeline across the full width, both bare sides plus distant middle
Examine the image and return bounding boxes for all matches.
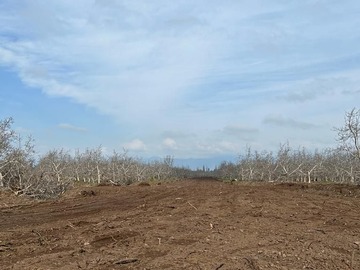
[0,109,360,197]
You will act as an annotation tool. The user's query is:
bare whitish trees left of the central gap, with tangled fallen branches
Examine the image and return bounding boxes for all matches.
[0,118,173,197]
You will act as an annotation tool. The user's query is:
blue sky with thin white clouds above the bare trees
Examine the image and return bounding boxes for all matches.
[0,0,360,167]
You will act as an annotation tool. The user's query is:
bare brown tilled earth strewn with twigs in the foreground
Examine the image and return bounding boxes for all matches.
[0,179,360,270]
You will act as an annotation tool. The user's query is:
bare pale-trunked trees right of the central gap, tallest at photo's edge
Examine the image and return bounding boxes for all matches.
[216,109,360,183]
